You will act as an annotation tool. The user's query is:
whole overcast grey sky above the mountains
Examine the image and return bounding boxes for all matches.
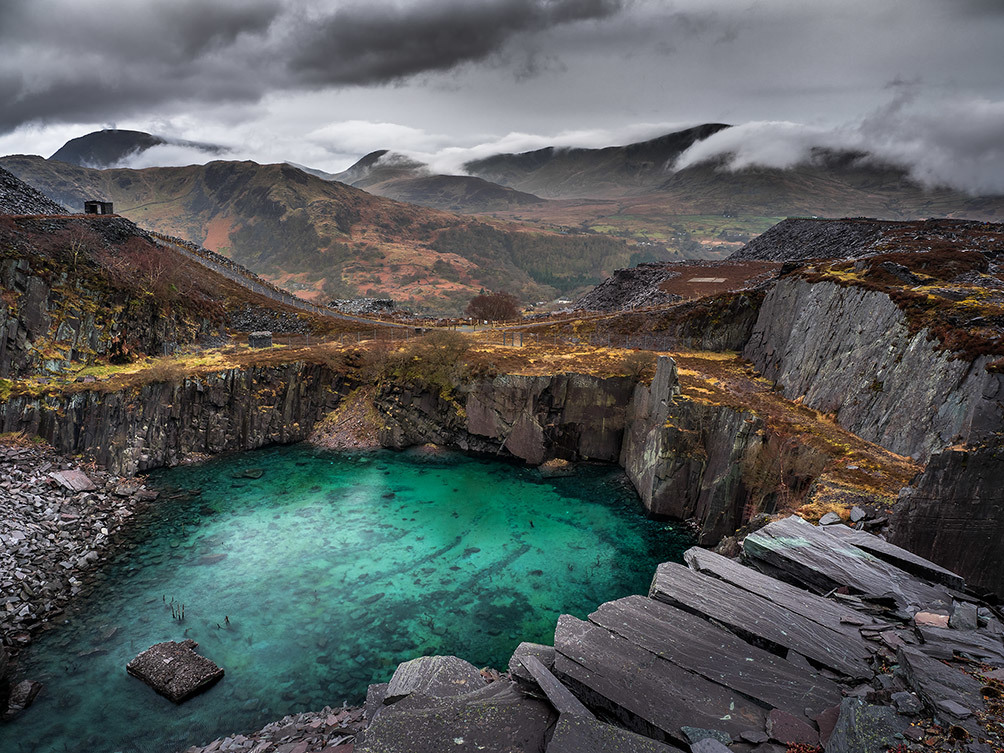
[0,0,1004,191]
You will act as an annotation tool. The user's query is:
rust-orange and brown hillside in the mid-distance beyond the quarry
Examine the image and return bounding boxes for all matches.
[0,156,632,311]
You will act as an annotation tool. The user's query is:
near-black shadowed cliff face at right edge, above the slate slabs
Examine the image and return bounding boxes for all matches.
[890,444,1004,598]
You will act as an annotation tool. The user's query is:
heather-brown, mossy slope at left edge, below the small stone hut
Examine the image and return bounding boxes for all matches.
[0,215,353,377]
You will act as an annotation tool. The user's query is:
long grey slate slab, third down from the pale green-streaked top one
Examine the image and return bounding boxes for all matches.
[649,562,872,679]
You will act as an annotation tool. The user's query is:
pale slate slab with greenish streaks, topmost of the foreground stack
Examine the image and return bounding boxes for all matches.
[743,515,952,608]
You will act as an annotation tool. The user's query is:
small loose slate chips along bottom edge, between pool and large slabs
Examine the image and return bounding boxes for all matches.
[185,706,365,753]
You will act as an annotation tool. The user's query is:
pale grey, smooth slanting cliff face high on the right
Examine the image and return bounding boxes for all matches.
[744,277,1004,460]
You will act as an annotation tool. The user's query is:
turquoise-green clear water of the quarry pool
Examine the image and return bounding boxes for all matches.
[0,446,687,753]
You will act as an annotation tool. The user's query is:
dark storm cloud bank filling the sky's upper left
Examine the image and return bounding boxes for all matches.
[0,0,621,133]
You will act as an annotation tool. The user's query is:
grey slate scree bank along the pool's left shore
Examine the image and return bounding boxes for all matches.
[0,438,158,716]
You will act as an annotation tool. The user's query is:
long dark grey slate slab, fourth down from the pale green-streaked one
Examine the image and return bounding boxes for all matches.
[589,596,840,715]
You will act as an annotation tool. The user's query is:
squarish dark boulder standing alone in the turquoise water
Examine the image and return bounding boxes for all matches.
[126,641,223,704]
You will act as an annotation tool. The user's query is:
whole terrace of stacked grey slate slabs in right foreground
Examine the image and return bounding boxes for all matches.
[355,517,1004,753]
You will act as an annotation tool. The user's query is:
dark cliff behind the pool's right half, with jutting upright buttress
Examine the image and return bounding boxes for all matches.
[377,356,799,544]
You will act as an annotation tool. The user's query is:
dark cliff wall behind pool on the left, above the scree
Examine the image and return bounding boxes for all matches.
[0,363,347,475]
